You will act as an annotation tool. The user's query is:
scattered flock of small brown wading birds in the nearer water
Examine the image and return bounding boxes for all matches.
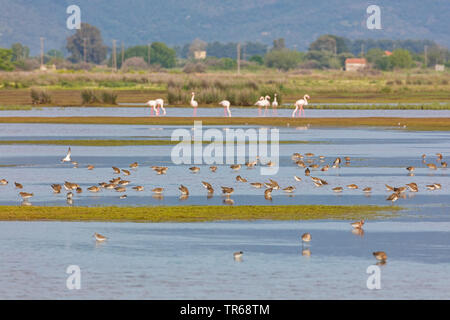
[0,147,447,264]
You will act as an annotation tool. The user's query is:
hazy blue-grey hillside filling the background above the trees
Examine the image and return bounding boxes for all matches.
[0,0,450,53]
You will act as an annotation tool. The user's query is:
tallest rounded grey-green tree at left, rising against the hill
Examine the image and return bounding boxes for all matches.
[67,23,108,64]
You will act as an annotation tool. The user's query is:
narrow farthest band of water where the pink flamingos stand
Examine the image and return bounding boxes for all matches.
[0,106,450,118]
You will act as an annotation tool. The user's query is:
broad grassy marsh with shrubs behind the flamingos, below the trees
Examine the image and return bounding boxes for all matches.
[0,70,450,106]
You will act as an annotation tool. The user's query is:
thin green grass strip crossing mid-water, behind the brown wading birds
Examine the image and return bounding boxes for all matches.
[0,140,324,147]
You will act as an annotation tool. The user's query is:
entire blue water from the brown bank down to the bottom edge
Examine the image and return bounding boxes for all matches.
[0,119,450,299]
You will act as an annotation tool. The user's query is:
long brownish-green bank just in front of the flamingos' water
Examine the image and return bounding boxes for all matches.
[0,117,450,131]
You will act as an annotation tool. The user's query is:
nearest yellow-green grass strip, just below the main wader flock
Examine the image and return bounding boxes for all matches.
[0,205,403,223]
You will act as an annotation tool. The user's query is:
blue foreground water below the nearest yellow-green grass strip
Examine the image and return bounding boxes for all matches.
[0,219,450,299]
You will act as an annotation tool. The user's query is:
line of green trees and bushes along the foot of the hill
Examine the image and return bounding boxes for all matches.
[0,23,450,72]
